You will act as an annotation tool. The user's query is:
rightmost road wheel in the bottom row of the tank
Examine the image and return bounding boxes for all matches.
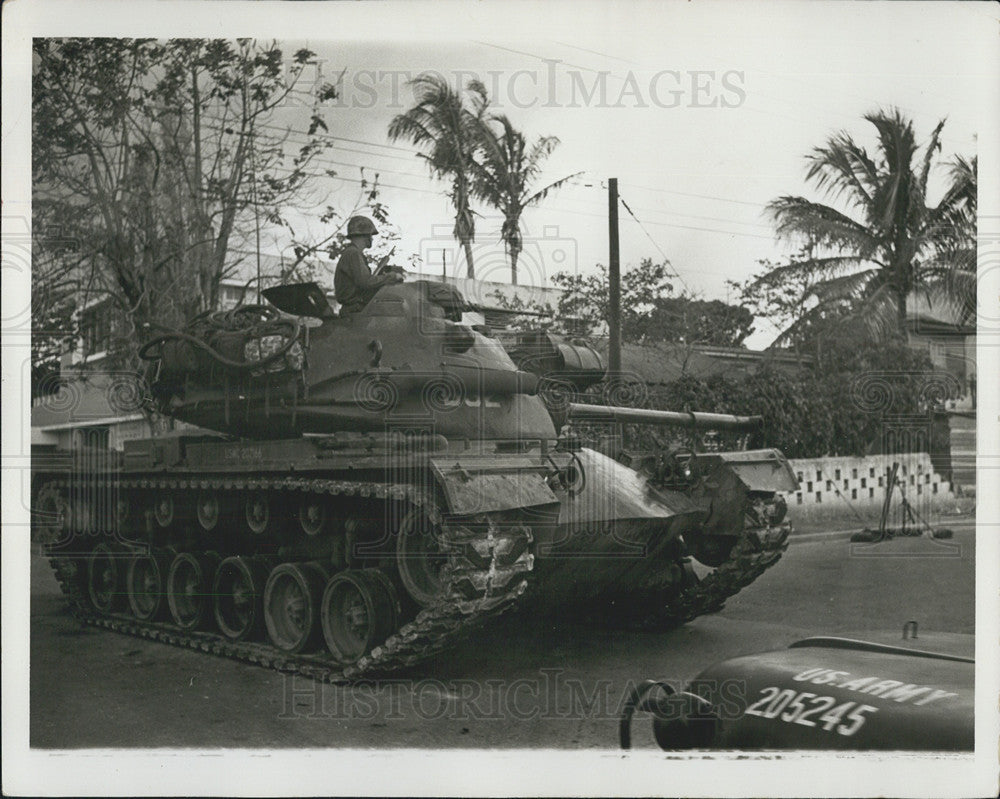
[320,569,398,666]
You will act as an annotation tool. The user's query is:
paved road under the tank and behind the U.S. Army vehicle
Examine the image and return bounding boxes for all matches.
[30,527,975,748]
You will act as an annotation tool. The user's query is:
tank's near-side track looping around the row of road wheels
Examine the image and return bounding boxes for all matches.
[42,478,533,683]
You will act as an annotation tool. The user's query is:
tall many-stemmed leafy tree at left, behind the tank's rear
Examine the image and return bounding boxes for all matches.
[32,34,334,378]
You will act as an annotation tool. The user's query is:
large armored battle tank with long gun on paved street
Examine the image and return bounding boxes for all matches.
[33,281,797,680]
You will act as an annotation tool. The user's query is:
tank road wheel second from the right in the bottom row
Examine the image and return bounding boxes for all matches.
[264,563,327,654]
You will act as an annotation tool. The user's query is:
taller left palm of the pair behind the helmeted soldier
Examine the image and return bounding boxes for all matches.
[389,74,489,277]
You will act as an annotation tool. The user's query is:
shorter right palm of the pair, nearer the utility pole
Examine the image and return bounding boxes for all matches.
[474,114,580,285]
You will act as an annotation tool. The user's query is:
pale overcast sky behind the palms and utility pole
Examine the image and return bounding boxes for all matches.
[252,3,995,345]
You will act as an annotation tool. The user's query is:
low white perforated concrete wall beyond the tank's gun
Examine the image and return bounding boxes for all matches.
[785,452,973,527]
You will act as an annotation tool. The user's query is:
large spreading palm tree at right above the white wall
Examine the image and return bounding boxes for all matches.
[757,110,977,338]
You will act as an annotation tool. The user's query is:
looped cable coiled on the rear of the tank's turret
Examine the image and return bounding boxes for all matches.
[139,305,302,371]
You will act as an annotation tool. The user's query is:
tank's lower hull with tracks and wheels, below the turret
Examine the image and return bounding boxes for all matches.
[36,433,787,680]
